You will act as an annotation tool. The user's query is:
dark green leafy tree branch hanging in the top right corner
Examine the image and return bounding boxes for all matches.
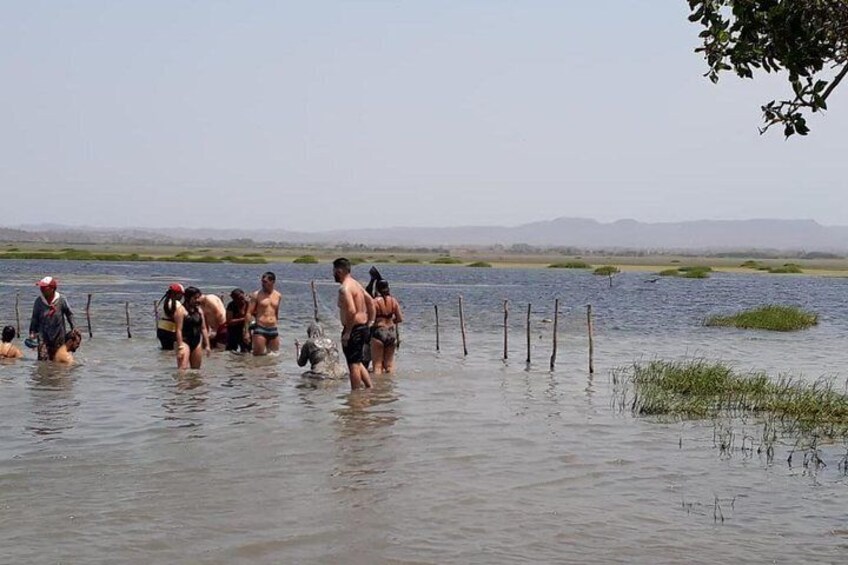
[688,0,848,137]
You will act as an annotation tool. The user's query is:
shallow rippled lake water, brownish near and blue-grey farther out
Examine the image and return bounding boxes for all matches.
[0,261,848,563]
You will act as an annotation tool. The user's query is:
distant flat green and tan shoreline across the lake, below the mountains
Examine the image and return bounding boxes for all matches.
[0,242,848,276]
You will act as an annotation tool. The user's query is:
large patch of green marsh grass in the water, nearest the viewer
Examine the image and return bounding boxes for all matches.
[613,360,848,437]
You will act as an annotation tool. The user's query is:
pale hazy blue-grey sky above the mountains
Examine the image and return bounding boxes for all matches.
[0,0,848,231]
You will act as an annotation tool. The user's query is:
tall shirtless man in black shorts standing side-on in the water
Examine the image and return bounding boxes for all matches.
[333,258,375,390]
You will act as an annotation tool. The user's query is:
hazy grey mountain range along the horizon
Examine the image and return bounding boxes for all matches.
[0,218,848,253]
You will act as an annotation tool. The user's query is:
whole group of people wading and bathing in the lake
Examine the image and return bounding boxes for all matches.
[0,258,403,389]
